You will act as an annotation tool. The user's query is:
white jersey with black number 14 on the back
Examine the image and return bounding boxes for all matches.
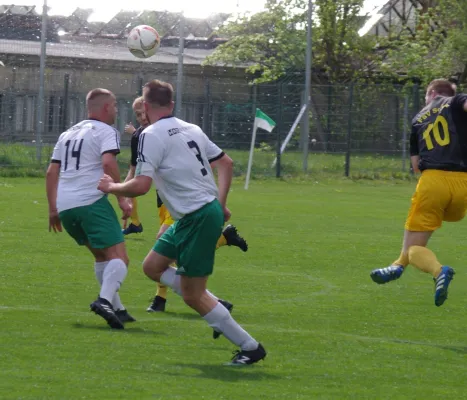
[51,120,120,212]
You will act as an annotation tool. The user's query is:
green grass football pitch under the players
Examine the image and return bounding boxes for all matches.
[0,178,467,400]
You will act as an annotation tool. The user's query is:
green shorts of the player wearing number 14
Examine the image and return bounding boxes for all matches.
[59,196,124,249]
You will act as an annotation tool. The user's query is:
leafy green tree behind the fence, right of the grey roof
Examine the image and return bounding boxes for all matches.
[205,0,374,83]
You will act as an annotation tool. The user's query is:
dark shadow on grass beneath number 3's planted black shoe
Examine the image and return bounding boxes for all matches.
[161,364,281,382]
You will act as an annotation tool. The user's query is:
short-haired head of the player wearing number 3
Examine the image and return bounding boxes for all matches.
[143,79,174,123]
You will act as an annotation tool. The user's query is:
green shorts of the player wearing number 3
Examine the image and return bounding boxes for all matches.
[153,200,224,277]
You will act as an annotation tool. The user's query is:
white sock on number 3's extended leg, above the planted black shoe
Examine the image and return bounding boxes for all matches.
[203,303,258,351]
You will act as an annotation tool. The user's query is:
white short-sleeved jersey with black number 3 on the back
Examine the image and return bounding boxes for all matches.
[136,117,224,220]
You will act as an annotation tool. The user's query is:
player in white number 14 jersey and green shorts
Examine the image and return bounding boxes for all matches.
[46,89,134,329]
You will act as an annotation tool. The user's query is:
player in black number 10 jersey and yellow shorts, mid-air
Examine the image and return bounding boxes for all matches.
[370,79,467,307]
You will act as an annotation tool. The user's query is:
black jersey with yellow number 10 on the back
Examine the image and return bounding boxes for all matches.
[410,94,467,172]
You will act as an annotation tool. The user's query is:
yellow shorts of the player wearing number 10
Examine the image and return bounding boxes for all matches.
[405,170,467,232]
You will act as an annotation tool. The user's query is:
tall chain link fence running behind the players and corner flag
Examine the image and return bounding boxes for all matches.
[0,62,422,178]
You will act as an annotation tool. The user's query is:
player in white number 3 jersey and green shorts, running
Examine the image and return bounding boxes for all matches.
[99,80,266,365]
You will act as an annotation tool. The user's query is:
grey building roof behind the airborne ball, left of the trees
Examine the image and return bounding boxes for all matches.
[0,5,234,65]
